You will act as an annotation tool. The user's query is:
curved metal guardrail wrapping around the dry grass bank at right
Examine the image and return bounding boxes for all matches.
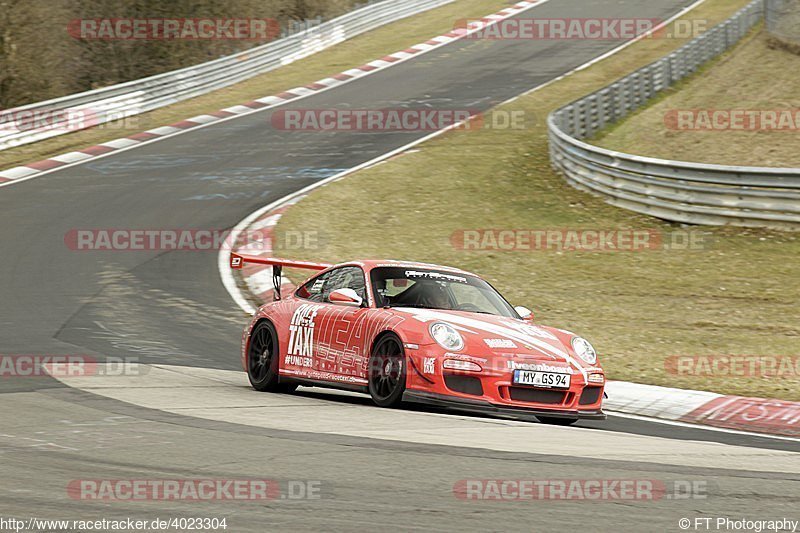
[548,0,800,229]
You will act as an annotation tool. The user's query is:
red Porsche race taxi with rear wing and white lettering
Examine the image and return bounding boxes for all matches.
[231,253,605,425]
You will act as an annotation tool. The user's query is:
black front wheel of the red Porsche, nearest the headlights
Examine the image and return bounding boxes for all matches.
[368,334,406,407]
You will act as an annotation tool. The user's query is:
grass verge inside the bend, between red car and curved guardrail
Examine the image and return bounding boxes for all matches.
[277,0,800,400]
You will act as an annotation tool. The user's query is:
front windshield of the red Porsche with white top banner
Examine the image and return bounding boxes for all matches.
[370,267,519,318]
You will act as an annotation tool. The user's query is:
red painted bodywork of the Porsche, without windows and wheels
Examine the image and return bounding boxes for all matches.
[241,258,605,418]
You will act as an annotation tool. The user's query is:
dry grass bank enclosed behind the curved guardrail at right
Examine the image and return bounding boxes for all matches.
[593,32,800,168]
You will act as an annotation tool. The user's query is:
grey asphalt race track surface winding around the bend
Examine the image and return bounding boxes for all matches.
[0,0,800,531]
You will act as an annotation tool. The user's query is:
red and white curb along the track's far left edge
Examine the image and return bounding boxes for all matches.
[0,0,548,184]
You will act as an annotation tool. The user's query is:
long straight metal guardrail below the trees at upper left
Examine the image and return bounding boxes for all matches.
[0,0,454,150]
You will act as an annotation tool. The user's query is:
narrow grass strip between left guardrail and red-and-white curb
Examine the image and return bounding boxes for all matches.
[0,0,509,169]
